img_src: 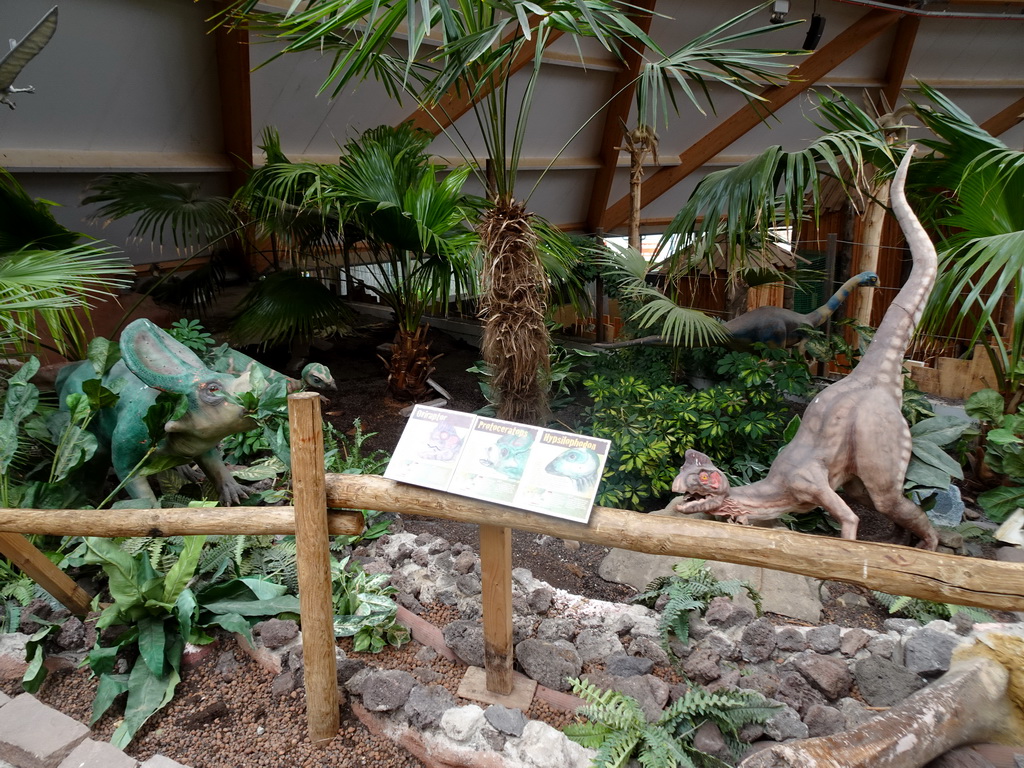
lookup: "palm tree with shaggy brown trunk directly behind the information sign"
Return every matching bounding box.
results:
[220,0,792,423]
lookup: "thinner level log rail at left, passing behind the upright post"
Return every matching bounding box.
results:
[0,507,364,539]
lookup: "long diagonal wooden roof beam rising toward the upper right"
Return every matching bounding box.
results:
[602,9,902,229]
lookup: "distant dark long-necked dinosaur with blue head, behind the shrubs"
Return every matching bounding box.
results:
[594,272,879,349]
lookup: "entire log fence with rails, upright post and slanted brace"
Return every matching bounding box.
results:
[0,394,1024,743]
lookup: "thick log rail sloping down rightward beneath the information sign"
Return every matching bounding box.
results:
[327,474,1024,610]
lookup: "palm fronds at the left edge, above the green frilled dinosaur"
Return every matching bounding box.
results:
[0,169,131,359]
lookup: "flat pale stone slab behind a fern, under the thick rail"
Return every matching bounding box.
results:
[598,548,821,624]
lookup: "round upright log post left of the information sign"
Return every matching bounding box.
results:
[288,392,341,745]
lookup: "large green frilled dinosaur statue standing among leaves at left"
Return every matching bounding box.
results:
[56,319,256,506]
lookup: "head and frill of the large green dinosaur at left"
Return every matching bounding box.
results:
[121,319,256,440]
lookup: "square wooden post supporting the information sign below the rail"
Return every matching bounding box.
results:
[480,525,514,695]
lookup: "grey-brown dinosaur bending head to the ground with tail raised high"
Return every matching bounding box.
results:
[672,147,938,550]
